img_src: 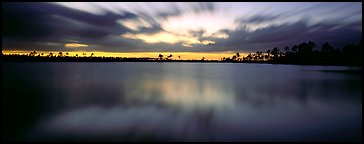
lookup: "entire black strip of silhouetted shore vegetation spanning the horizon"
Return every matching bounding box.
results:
[1,41,362,66]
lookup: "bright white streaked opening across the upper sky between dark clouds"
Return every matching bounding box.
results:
[55,2,362,36]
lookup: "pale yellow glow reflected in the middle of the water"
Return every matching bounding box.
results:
[134,76,235,109]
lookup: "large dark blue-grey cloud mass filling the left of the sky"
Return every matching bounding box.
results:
[2,3,137,50]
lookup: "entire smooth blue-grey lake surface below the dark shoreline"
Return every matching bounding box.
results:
[2,63,362,141]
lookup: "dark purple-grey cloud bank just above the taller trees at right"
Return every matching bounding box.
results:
[208,19,362,52]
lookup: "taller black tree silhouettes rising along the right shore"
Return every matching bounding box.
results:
[221,41,362,66]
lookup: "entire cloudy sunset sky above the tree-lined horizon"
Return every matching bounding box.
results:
[2,2,362,58]
